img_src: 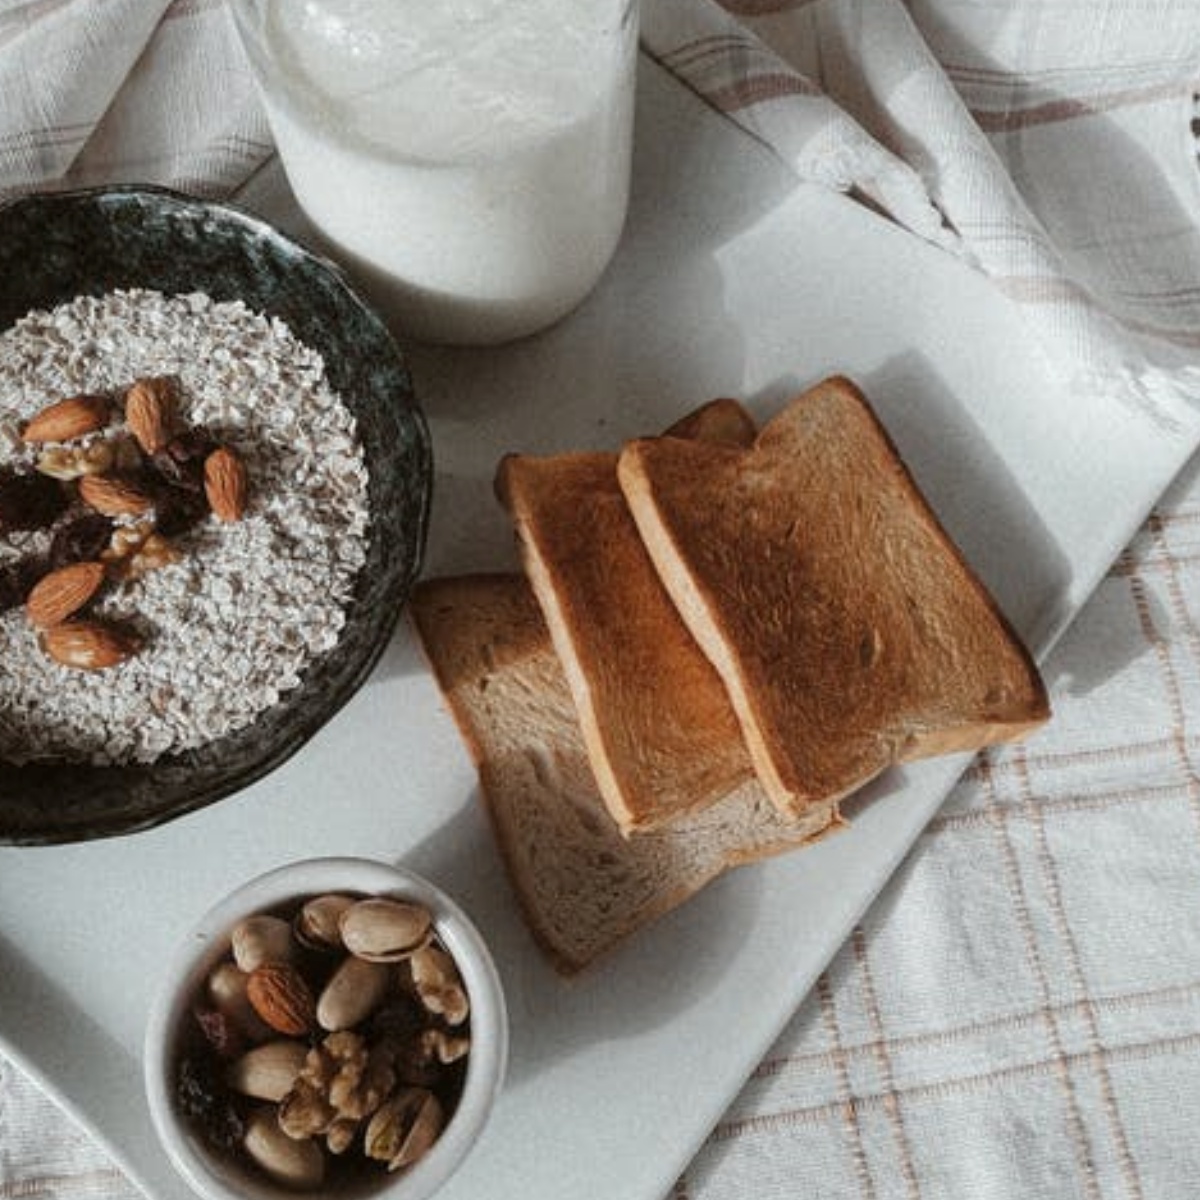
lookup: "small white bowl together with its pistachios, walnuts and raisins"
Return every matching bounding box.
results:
[144,858,508,1200]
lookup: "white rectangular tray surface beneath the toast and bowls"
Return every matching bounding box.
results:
[7,64,1196,1200]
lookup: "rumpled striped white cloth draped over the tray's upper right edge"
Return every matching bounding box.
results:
[643,0,1200,421]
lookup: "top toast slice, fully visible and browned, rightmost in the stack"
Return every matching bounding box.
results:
[618,378,1049,812]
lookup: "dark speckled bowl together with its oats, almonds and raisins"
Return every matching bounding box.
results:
[0,187,432,845]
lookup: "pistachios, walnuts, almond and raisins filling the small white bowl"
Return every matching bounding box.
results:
[175,894,470,1190]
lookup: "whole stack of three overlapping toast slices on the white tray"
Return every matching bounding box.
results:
[410,377,1049,973]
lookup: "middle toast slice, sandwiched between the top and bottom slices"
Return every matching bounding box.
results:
[496,400,756,834]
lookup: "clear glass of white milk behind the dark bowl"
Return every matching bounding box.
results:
[226,0,637,343]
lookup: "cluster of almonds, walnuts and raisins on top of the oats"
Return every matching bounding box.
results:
[0,376,247,671]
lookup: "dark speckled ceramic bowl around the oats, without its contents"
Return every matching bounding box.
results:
[0,187,433,845]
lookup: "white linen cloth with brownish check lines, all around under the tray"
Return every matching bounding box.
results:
[0,0,1200,1200]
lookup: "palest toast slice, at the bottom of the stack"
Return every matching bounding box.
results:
[409,575,840,974]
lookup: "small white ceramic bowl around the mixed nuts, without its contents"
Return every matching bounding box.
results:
[144,858,508,1200]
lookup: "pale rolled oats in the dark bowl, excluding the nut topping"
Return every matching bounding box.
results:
[0,290,368,763]
